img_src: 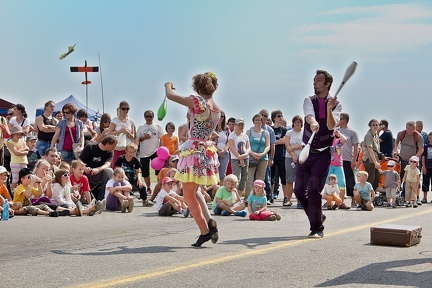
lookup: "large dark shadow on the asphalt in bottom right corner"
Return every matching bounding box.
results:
[315,258,432,287]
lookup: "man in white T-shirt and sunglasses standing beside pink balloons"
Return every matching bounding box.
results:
[136,110,163,194]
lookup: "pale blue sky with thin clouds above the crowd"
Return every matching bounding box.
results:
[0,0,432,138]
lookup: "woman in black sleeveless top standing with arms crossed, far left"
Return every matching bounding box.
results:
[36,100,59,157]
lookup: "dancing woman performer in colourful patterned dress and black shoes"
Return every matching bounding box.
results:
[165,72,220,247]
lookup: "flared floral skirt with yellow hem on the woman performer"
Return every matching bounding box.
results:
[174,139,219,185]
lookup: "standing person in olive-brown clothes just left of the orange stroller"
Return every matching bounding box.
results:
[358,119,381,191]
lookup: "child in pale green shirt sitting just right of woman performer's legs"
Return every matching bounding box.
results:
[212,174,247,217]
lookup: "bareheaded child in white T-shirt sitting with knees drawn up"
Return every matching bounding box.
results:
[105,167,134,213]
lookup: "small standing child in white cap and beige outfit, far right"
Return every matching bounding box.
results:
[403,156,420,208]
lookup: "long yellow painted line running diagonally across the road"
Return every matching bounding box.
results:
[74,209,432,288]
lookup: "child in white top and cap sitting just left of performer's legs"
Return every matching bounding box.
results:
[156,177,189,218]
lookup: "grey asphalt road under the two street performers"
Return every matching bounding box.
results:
[0,200,432,288]
